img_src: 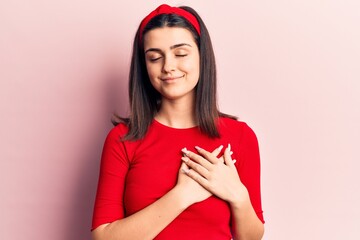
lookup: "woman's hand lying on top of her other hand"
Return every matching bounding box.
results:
[182,144,248,205]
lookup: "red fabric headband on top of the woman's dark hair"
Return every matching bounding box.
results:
[139,4,200,41]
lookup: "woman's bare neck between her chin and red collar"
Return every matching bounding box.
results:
[155,96,197,128]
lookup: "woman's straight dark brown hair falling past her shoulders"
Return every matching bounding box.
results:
[112,6,235,140]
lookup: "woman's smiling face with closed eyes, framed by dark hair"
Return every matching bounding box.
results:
[144,27,200,100]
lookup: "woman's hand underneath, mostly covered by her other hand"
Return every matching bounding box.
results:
[176,146,223,206]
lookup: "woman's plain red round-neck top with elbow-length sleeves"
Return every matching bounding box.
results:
[92,118,264,240]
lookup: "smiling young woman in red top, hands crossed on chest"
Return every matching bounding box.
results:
[92,5,264,240]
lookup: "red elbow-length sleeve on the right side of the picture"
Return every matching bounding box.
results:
[236,124,265,223]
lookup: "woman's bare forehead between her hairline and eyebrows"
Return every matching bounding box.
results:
[144,27,196,49]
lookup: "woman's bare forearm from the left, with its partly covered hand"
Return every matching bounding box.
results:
[92,160,211,240]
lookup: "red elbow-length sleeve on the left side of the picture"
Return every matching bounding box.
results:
[91,127,129,230]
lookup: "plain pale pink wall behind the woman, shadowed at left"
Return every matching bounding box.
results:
[0,0,360,240]
